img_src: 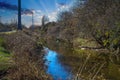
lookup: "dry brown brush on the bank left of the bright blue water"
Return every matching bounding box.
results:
[6,31,48,80]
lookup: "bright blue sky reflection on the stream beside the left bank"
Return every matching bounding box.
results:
[45,49,71,80]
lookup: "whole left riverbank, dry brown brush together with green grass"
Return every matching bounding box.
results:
[0,31,49,80]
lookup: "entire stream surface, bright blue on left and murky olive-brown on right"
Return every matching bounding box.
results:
[44,41,120,80]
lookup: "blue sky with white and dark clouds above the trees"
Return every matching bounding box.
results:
[0,0,75,27]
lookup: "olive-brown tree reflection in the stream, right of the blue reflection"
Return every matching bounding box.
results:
[44,38,119,80]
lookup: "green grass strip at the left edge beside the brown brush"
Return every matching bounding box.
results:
[0,37,11,79]
